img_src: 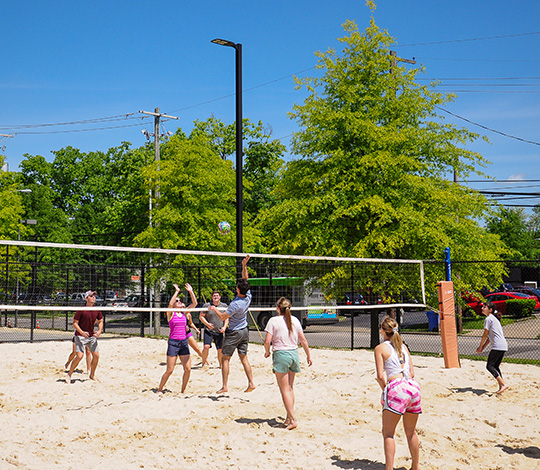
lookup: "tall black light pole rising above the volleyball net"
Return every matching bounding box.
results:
[211,39,244,253]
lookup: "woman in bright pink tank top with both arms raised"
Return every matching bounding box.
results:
[157,283,197,393]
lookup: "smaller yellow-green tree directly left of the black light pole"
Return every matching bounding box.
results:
[136,133,235,251]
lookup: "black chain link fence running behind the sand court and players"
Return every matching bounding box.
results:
[0,241,540,361]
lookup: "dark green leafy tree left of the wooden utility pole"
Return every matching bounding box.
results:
[21,142,150,245]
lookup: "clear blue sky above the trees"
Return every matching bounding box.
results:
[0,0,540,209]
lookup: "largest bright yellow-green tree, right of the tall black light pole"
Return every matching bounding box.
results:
[260,20,504,298]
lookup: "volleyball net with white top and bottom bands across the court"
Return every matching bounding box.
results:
[0,240,426,335]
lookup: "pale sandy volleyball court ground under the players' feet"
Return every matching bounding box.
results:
[0,338,540,470]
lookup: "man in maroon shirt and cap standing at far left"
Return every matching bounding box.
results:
[66,290,103,384]
